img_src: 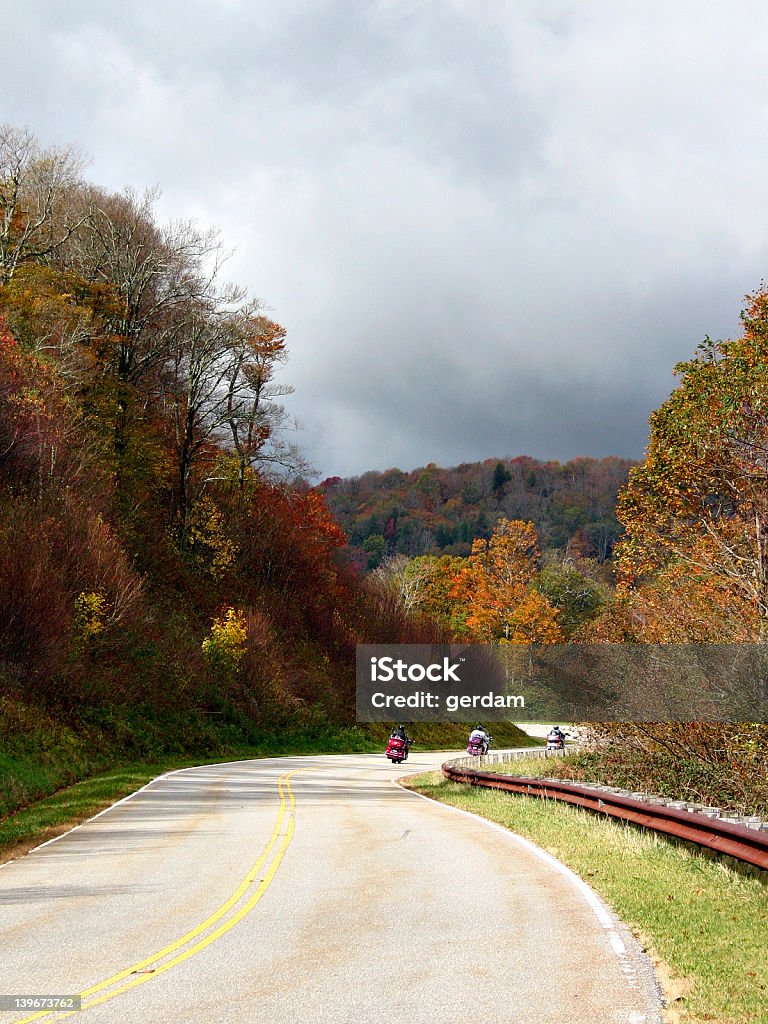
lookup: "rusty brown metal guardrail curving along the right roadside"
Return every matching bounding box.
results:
[442,761,768,869]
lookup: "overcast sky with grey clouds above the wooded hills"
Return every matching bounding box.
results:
[0,0,768,476]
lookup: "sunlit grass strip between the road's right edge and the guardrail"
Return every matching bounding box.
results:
[408,760,768,1024]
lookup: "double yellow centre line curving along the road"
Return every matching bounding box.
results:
[16,768,302,1024]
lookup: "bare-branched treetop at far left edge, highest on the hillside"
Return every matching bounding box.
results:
[0,124,87,285]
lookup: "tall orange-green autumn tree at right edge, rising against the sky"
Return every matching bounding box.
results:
[618,288,768,640]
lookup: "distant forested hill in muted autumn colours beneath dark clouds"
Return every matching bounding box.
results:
[321,456,635,568]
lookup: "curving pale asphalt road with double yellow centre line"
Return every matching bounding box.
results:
[0,752,659,1024]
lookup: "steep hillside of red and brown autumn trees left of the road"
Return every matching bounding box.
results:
[0,125,462,790]
